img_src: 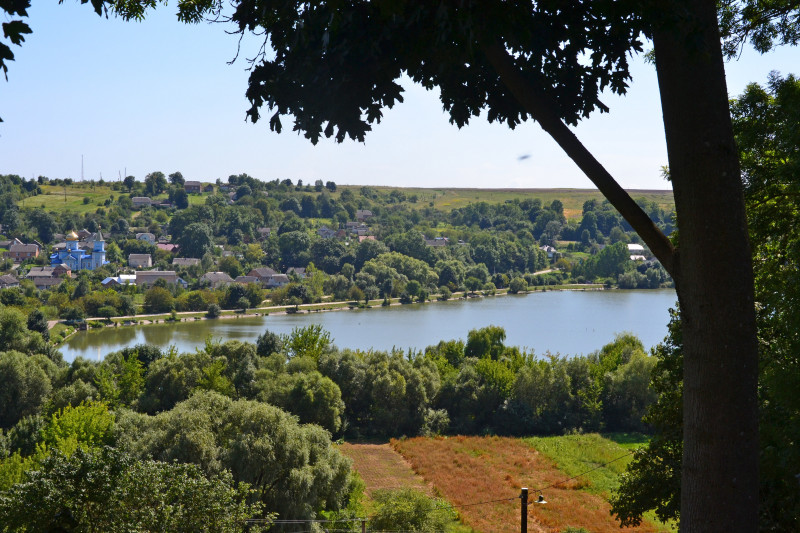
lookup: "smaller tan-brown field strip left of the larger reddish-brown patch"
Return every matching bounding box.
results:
[339,443,433,495]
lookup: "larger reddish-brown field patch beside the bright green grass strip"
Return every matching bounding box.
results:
[391,437,656,533]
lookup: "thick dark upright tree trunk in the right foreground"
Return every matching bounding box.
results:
[653,1,758,533]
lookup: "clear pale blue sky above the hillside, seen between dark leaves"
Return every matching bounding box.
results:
[0,0,800,189]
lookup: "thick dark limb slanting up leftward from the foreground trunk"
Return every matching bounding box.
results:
[483,42,677,278]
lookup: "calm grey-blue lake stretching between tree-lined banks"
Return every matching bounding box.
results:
[61,289,676,361]
